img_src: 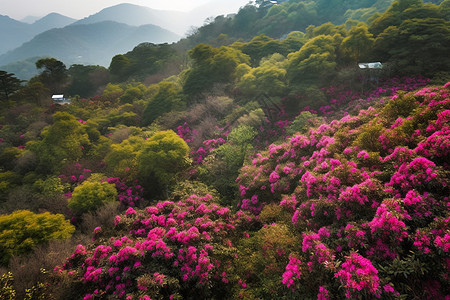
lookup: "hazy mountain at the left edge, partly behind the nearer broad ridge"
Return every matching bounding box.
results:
[0,13,76,54]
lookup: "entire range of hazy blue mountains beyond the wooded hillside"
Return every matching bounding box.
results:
[0,0,248,77]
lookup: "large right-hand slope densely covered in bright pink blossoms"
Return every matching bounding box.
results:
[237,83,450,299]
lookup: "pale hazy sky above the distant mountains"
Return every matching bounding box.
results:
[0,0,249,20]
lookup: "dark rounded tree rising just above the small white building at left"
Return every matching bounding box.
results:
[36,58,69,93]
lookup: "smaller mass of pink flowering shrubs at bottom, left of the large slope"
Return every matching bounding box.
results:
[60,195,252,299]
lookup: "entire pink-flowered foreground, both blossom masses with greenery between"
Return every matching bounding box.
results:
[60,83,450,299]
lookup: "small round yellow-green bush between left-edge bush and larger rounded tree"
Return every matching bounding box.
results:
[68,175,117,215]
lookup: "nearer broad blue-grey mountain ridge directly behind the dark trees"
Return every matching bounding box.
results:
[0,21,180,66]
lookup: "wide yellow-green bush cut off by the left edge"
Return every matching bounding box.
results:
[0,210,75,265]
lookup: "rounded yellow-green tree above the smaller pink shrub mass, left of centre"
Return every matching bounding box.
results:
[137,130,190,197]
